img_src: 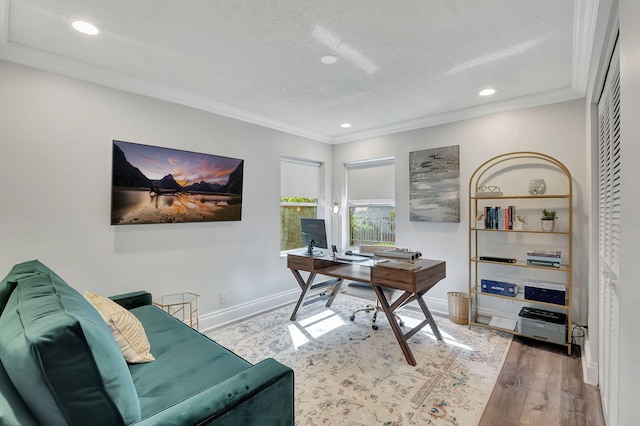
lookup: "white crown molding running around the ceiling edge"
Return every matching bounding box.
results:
[0,0,599,144]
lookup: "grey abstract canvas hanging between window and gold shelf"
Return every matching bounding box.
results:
[409,145,460,222]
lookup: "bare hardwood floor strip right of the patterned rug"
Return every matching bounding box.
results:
[480,337,605,426]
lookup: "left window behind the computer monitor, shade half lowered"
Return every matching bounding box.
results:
[280,158,322,251]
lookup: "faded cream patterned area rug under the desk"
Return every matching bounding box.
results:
[207,294,511,426]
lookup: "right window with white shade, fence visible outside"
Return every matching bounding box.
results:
[345,158,396,246]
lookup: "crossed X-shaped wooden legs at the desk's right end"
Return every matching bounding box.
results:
[373,285,442,366]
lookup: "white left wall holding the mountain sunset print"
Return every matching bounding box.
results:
[0,62,331,326]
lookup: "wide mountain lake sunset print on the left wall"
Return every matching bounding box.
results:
[111,140,244,225]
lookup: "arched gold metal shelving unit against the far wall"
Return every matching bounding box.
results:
[469,152,573,354]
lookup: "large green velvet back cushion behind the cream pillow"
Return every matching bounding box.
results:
[0,264,140,425]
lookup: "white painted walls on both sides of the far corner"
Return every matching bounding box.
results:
[0,62,586,327]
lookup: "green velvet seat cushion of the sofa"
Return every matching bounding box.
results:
[129,306,251,418]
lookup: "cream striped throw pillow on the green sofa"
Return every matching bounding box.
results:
[84,291,155,364]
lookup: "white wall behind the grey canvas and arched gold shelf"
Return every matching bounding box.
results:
[333,100,587,324]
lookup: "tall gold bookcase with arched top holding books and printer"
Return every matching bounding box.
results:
[468,151,573,354]
